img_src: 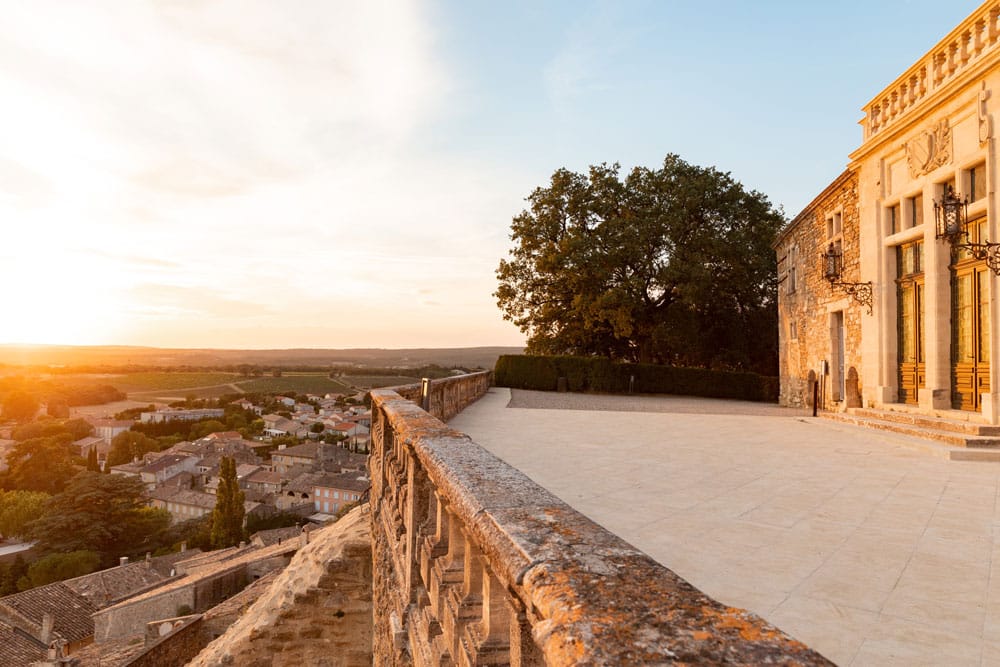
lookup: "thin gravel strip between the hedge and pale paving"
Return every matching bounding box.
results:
[507,389,807,417]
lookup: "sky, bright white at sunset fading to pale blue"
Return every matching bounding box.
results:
[0,0,979,348]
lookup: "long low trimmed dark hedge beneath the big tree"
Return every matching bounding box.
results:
[494,354,778,402]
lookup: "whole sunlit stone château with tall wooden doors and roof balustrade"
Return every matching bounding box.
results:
[775,2,1000,424]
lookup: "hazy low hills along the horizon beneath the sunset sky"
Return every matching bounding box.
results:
[0,345,524,368]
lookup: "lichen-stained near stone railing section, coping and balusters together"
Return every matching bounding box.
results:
[370,378,830,665]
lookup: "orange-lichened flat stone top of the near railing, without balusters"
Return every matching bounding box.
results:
[371,390,832,665]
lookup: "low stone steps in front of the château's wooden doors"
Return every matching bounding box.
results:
[820,406,1000,463]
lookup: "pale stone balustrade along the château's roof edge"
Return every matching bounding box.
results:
[861,3,1000,141]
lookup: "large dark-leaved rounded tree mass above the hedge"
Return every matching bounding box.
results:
[494,155,784,375]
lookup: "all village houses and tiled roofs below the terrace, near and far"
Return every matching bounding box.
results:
[0,394,371,666]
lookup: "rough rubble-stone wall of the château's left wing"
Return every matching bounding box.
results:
[775,170,867,410]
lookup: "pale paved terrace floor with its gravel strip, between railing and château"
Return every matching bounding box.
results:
[450,388,1000,666]
